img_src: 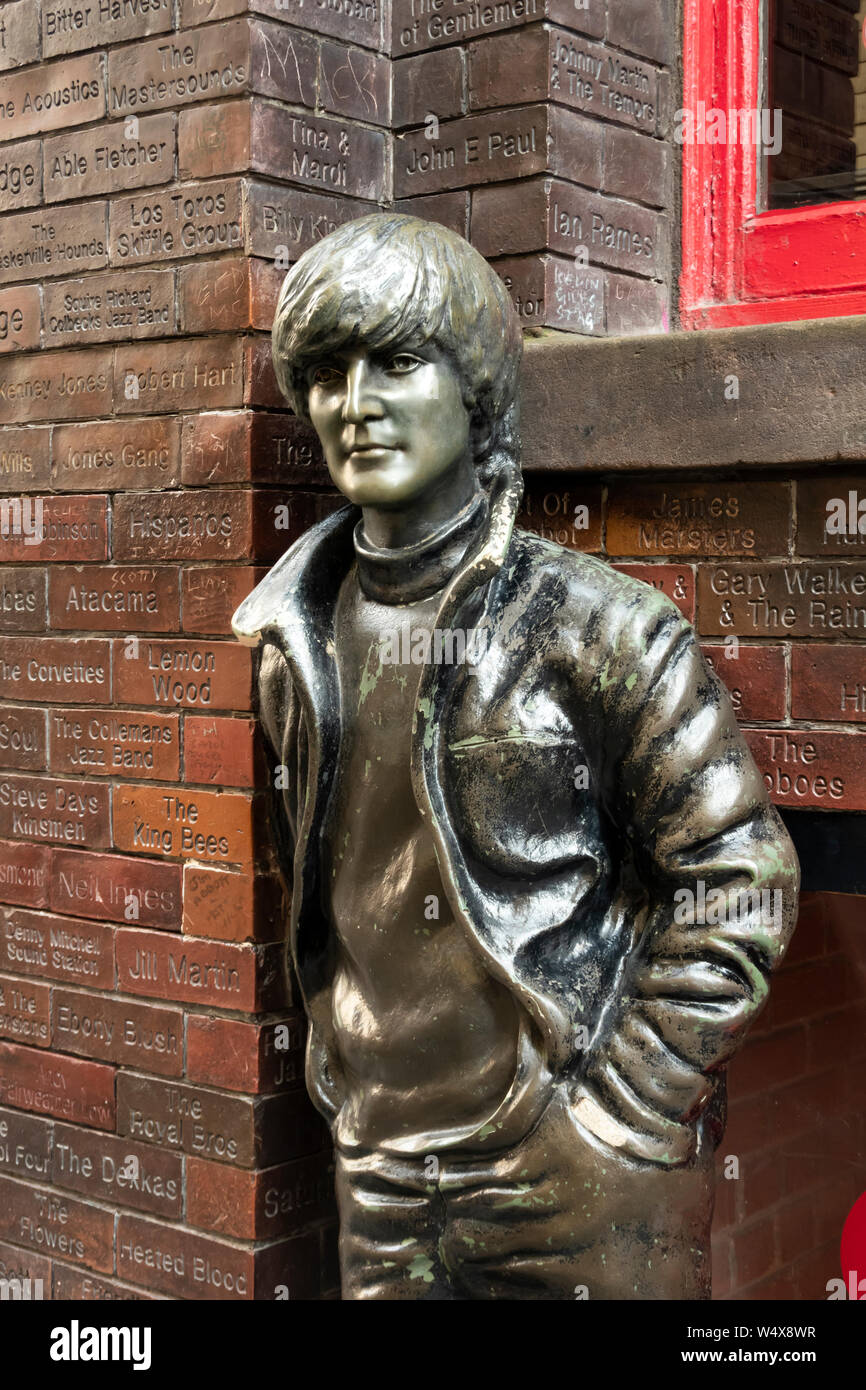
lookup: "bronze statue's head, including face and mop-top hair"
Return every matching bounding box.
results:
[272,213,523,506]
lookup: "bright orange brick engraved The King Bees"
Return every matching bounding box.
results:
[112,783,253,865]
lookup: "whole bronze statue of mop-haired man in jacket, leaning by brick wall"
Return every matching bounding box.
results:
[234,214,798,1300]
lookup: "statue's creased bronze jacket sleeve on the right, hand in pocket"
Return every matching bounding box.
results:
[574,595,799,1165]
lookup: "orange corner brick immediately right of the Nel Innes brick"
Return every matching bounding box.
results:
[183,862,285,941]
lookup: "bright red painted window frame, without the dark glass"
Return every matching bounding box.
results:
[680,0,866,328]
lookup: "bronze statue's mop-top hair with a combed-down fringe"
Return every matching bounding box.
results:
[272,213,523,480]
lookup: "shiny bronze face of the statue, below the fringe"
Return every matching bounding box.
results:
[307,343,470,509]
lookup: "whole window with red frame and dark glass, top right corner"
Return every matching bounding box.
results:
[677,0,866,328]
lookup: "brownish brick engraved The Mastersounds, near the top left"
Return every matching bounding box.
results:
[108,19,250,115]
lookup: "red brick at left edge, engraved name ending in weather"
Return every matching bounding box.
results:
[0,1043,114,1128]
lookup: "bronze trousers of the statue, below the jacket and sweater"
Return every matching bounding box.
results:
[336,1083,713,1301]
